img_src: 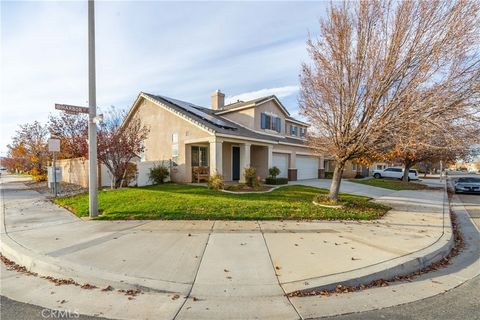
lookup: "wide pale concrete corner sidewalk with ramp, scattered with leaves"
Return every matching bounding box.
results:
[1,176,458,319]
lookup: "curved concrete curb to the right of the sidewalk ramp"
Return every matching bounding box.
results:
[281,184,455,293]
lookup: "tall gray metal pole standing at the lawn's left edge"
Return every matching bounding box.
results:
[88,0,98,217]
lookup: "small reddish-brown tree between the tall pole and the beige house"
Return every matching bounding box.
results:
[98,107,149,188]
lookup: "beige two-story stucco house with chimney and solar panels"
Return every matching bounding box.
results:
[124,90,324,182]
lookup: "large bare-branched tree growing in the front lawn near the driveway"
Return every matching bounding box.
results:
[299,0,480,200]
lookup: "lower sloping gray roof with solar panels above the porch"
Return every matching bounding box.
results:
[143,92,304,146]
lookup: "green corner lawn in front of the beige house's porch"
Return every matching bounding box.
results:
[55,184,389,220]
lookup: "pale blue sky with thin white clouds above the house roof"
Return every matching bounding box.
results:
[0,1,328,155]
